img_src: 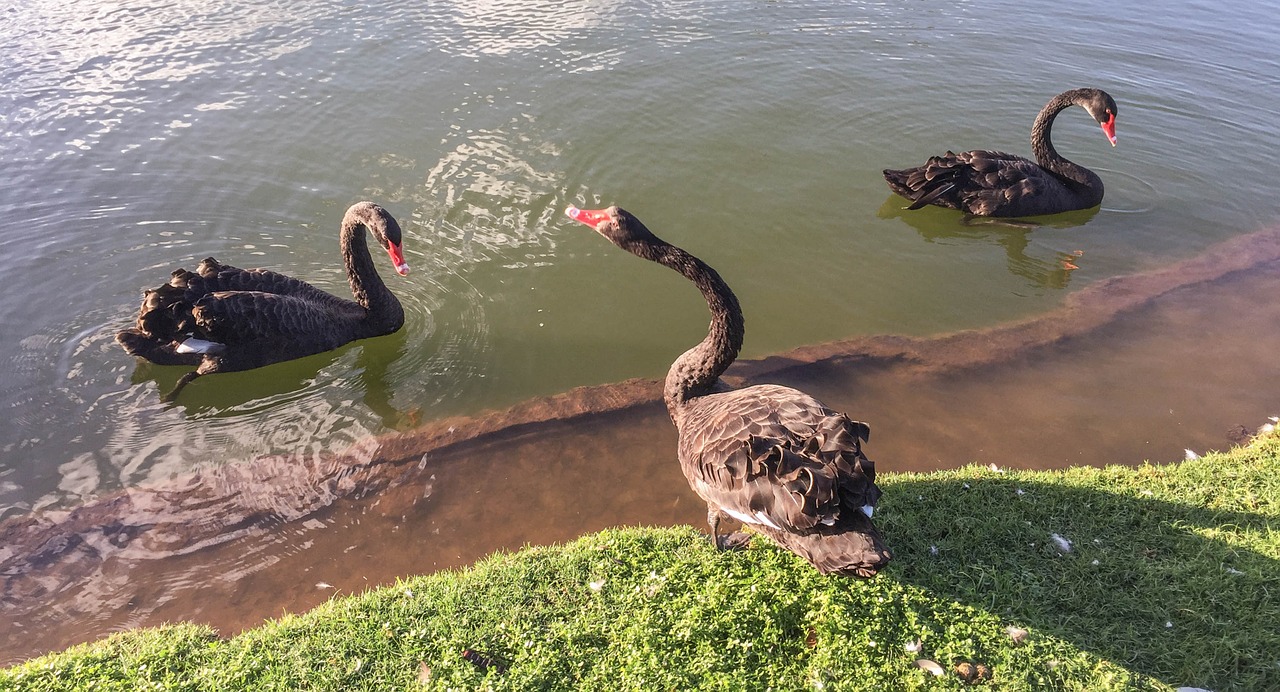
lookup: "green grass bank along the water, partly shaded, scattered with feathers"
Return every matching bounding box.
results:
[0,435,1280,692]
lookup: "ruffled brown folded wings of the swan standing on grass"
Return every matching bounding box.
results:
[680,385,879,532]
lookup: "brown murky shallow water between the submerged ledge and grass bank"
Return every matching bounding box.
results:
[0,230,1280,663]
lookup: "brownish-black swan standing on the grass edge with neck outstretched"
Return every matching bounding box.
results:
[567,206,890,577]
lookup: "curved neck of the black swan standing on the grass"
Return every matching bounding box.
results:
[628,240,744,426]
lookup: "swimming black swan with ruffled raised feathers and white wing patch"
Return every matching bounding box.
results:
[115,202,408,399]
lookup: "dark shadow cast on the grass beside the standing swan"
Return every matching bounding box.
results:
[877,469,1280,689]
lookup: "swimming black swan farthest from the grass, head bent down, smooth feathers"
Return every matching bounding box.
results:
[884,88,1116,216]
